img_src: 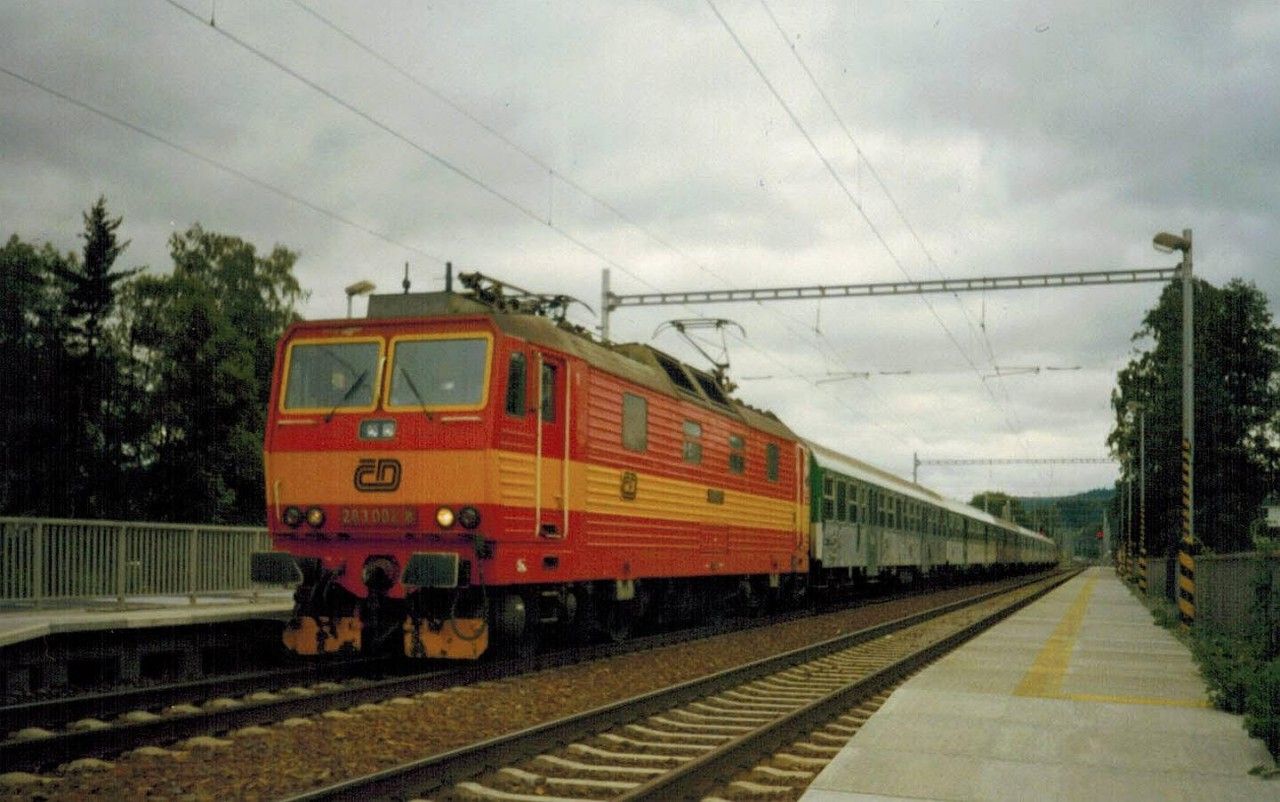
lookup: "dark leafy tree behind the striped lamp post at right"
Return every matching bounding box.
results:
[1107,279,1280,554]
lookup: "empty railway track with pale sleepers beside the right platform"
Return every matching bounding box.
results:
[288,574,1074,802]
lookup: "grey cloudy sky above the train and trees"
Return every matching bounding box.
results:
[0,0,1280,498]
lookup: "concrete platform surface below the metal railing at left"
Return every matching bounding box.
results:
[0,590,293,647]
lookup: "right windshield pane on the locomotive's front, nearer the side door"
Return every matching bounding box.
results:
[387,336,490,409]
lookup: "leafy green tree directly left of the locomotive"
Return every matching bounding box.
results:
[129,225,303,523]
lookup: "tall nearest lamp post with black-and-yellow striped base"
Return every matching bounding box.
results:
[1151,229,1196,627]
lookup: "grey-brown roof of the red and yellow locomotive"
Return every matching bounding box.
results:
[367,292,799,440]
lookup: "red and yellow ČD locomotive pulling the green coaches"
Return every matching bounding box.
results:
[253,274,809,659]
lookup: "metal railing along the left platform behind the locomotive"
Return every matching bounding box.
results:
[0,517,271,605]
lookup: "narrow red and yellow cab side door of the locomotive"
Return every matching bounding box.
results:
[534,352,570,537]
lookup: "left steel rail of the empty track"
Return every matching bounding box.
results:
[275,572,1078,802]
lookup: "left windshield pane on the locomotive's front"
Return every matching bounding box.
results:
[284,340,379,412]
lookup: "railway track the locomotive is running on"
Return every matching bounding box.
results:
[0,570,1039,771]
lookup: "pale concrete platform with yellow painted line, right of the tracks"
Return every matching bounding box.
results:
[801,568,1280,802]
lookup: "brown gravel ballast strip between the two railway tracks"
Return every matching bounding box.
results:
[0,583,1039,802]
